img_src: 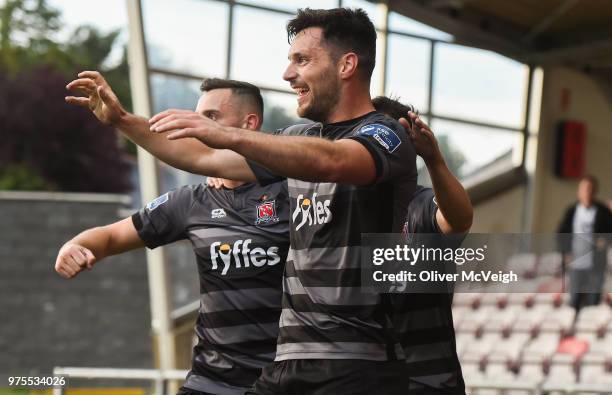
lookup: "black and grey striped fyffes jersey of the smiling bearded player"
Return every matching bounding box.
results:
[250,112,416,361]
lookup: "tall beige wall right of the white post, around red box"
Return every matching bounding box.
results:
[533,68,612,232]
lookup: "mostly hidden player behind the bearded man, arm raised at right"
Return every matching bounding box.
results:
[372,96,474,395]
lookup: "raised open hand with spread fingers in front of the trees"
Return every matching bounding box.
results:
[66,71,126,125]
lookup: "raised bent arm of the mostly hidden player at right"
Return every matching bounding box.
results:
[400,112,474,234]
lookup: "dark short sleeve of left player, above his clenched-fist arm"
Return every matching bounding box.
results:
[132,185,200,248]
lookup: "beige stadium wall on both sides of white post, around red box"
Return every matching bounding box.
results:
[472,67,612,232]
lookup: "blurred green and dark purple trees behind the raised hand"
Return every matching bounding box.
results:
[0,0,131,192]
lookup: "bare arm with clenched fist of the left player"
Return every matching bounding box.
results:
[55,218,144,278]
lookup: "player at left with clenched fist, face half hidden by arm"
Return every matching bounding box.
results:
[61,74,289,395]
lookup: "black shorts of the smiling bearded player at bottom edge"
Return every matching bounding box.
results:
[246,359,409,395]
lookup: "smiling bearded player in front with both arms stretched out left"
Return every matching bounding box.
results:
[69,8,416,394]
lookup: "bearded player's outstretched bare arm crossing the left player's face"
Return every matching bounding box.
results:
[150,110,376,185]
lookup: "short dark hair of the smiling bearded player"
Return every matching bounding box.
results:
[287,8,376,81]
